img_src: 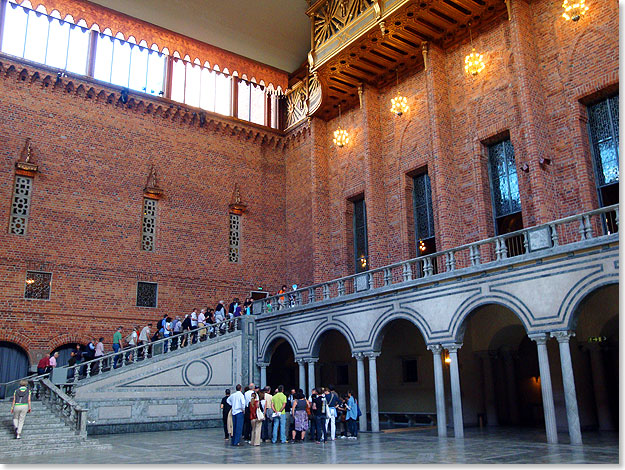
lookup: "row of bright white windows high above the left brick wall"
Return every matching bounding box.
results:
[0,0,278,128]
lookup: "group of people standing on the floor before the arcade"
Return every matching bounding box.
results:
[220,383,361,446]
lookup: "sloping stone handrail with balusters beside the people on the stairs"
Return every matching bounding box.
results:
[60,316,243,384]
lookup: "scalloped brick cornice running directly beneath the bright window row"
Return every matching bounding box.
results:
[0,54,286,150]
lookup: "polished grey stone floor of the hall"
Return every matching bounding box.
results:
[0,428,619,464]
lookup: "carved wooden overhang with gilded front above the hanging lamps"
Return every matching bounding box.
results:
[304,0,507,120]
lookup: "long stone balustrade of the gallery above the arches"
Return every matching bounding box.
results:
[253,204,619,315]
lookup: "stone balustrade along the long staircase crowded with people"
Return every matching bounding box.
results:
[58,317,242,384]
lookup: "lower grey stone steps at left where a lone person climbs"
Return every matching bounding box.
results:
[0,400,111,456]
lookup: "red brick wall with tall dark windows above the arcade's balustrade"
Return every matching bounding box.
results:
[286,0,618,282]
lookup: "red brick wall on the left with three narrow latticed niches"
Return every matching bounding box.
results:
[0,59,286,361]
